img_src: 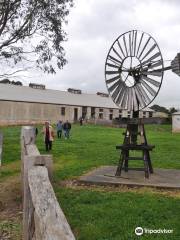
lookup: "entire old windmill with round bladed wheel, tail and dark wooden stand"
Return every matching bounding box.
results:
[105,30,180,178]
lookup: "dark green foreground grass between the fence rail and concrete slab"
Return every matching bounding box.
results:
[56,188,180,240]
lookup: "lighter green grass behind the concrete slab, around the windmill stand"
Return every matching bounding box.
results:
[37,125,180,179]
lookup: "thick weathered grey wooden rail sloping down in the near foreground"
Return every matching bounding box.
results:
[28,166,75,240]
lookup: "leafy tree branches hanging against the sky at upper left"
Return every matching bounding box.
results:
[0,0,73,78]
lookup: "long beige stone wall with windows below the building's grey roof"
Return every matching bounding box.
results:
[0,100,167,125]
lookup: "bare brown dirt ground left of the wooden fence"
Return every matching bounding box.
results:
[0,176,22,240]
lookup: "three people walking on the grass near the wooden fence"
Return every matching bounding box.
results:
[42,121,71,151]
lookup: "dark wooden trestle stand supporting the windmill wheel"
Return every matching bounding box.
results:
[115,112,155,178]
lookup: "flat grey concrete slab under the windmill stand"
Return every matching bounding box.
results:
[78,166,180,189]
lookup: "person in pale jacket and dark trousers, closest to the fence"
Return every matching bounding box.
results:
[42,121,54,151]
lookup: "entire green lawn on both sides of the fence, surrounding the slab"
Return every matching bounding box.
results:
[0,125,180,240]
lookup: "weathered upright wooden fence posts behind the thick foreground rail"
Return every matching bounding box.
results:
[21,126,52,240]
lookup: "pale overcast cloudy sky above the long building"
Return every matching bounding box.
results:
[23,0,180,108]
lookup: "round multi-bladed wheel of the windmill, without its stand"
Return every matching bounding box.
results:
[105,30,165,111]
